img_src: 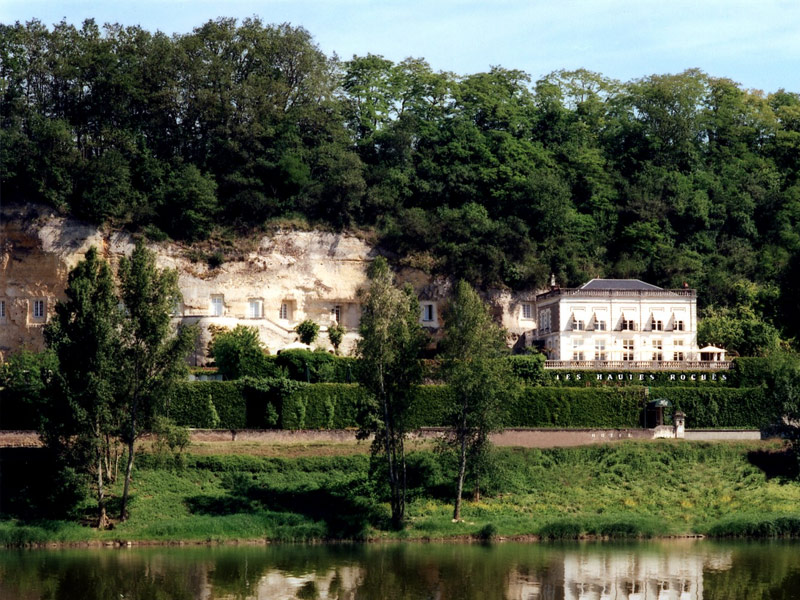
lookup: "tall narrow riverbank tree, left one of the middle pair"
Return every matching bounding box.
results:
[356,257,427,529]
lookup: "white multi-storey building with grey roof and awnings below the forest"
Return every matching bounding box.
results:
[534,279,712,369]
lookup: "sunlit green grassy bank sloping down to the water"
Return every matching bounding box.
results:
[0,441,800,544]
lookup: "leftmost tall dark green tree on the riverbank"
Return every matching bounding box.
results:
[40,247,121,529]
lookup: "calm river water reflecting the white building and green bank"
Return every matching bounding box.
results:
[0,540,800,600]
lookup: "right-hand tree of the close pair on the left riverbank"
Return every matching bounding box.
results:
[116,241,197,520]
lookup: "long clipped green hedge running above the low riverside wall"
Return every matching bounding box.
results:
[164,379,780,429]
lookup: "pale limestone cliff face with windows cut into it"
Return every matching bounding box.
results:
[0,206,533,365]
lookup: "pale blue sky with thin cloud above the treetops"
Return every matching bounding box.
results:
[0,0,800,92]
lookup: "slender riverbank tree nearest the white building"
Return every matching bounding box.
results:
[441,281,514,520]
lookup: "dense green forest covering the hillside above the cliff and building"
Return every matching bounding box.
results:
[0,19,800,354]
